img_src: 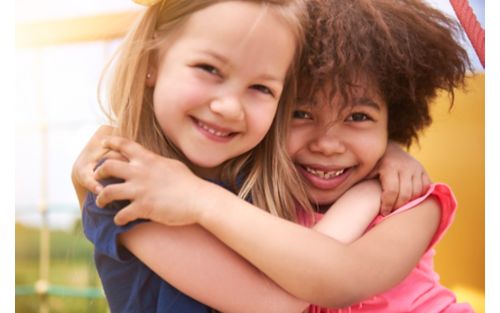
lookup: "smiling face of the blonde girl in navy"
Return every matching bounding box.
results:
[152,1,295,178]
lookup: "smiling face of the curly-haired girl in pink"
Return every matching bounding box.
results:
[287,85,388,205]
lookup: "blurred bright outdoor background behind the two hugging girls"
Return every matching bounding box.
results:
[15,0,485,313]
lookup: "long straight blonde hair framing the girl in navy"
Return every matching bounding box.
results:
[100,0,309,221]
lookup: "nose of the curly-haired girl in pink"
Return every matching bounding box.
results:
[309,127,346,156]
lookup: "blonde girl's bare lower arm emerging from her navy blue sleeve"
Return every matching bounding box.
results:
[122,223,308,313]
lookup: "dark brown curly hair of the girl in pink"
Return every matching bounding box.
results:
[299,0,470,146]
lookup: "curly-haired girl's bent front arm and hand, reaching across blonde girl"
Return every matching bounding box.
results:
[96,138,439,307]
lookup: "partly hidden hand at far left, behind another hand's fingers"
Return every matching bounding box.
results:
[71,125,116,207]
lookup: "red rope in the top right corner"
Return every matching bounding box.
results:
[450,0,485,68]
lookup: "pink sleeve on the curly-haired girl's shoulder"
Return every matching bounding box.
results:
[373,183,457,249]
